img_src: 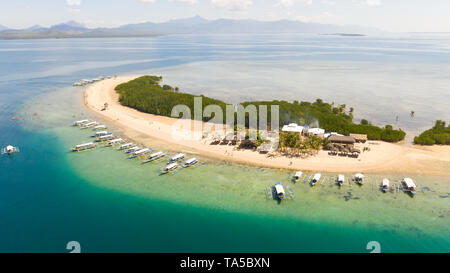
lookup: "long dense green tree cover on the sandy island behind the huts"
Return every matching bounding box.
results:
[116,76,405,142]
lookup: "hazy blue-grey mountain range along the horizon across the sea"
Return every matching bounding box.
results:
[0,16,381,39]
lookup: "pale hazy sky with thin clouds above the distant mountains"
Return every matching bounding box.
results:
[0,0,450,32]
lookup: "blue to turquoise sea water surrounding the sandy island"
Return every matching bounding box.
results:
[0,35,450,252]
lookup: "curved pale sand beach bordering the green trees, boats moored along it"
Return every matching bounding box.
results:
[84,76,450,175]
